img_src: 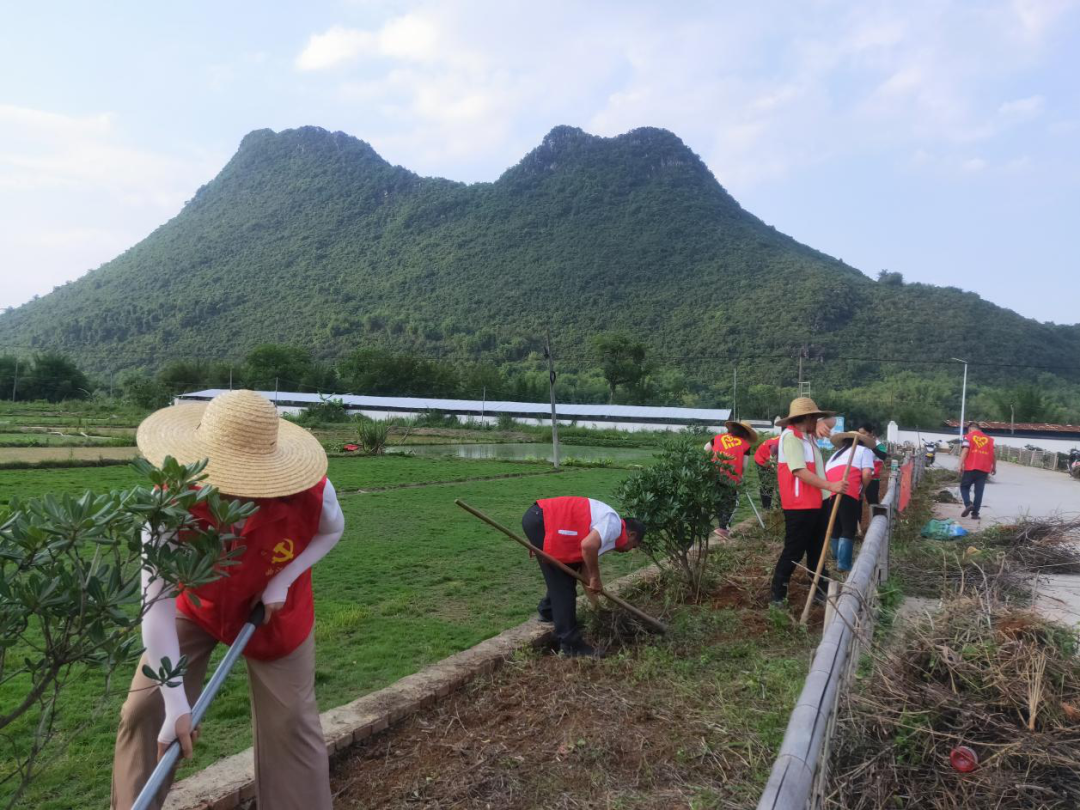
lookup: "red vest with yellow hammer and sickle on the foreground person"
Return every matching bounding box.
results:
[176,478,326,661]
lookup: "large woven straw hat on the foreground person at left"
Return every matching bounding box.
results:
[135,391,326,498]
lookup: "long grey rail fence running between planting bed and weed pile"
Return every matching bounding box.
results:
[757,453,923,810]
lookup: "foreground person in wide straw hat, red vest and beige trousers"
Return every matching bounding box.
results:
[112,391,345,810]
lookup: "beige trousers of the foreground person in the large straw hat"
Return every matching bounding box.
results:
[112,618,332,810]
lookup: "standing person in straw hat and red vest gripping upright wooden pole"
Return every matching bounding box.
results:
[772,396,847,604]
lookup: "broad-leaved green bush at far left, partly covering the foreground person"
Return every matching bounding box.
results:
[0,458,255,807]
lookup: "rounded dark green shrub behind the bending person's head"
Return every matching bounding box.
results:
[619,435,737,592]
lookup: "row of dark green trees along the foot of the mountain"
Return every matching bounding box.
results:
[0,343,1080,427]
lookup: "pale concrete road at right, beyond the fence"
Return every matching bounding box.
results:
[934,455,1080,625]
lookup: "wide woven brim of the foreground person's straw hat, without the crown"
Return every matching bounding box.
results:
[135,403,327,498]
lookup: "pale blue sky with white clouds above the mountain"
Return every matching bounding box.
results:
[0,0,1080,323]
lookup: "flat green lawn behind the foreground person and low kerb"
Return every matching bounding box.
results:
[0,457,646,810]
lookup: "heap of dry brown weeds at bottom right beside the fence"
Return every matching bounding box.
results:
[825,599,1080,810]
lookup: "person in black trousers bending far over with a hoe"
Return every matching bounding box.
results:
[522,497,645,658]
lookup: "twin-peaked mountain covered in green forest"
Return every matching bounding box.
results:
[0,126,1080,384]
